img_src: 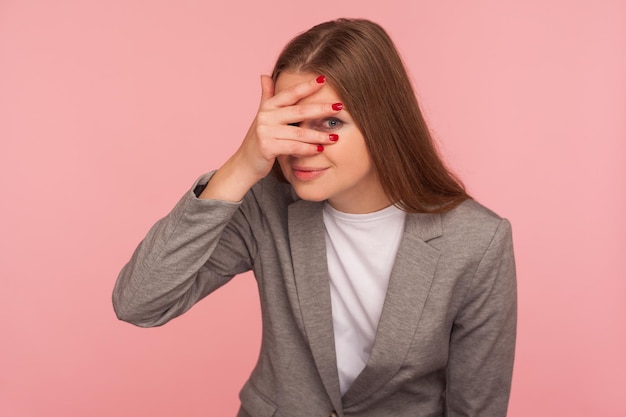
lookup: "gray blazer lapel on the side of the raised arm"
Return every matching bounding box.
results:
[288,200,342,410]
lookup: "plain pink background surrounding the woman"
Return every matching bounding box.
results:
[0,0,626,417]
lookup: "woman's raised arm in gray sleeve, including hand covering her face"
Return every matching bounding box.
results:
[113,76,339,327]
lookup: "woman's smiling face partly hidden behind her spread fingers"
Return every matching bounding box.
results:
[275,72,391,213]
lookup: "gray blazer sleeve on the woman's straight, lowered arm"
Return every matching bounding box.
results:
[446,219,517,417]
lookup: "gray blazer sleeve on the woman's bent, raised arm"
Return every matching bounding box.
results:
[113,174,255,327]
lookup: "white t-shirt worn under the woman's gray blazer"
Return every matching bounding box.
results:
[324,203,406,395]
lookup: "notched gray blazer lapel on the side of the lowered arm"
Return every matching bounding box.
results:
[343,214,442,407]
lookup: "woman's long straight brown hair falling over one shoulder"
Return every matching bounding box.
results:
[272,19,470,213]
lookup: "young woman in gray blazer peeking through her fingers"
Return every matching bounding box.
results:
[113,19,516,417]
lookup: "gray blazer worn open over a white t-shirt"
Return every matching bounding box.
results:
[113,174,516,417]
